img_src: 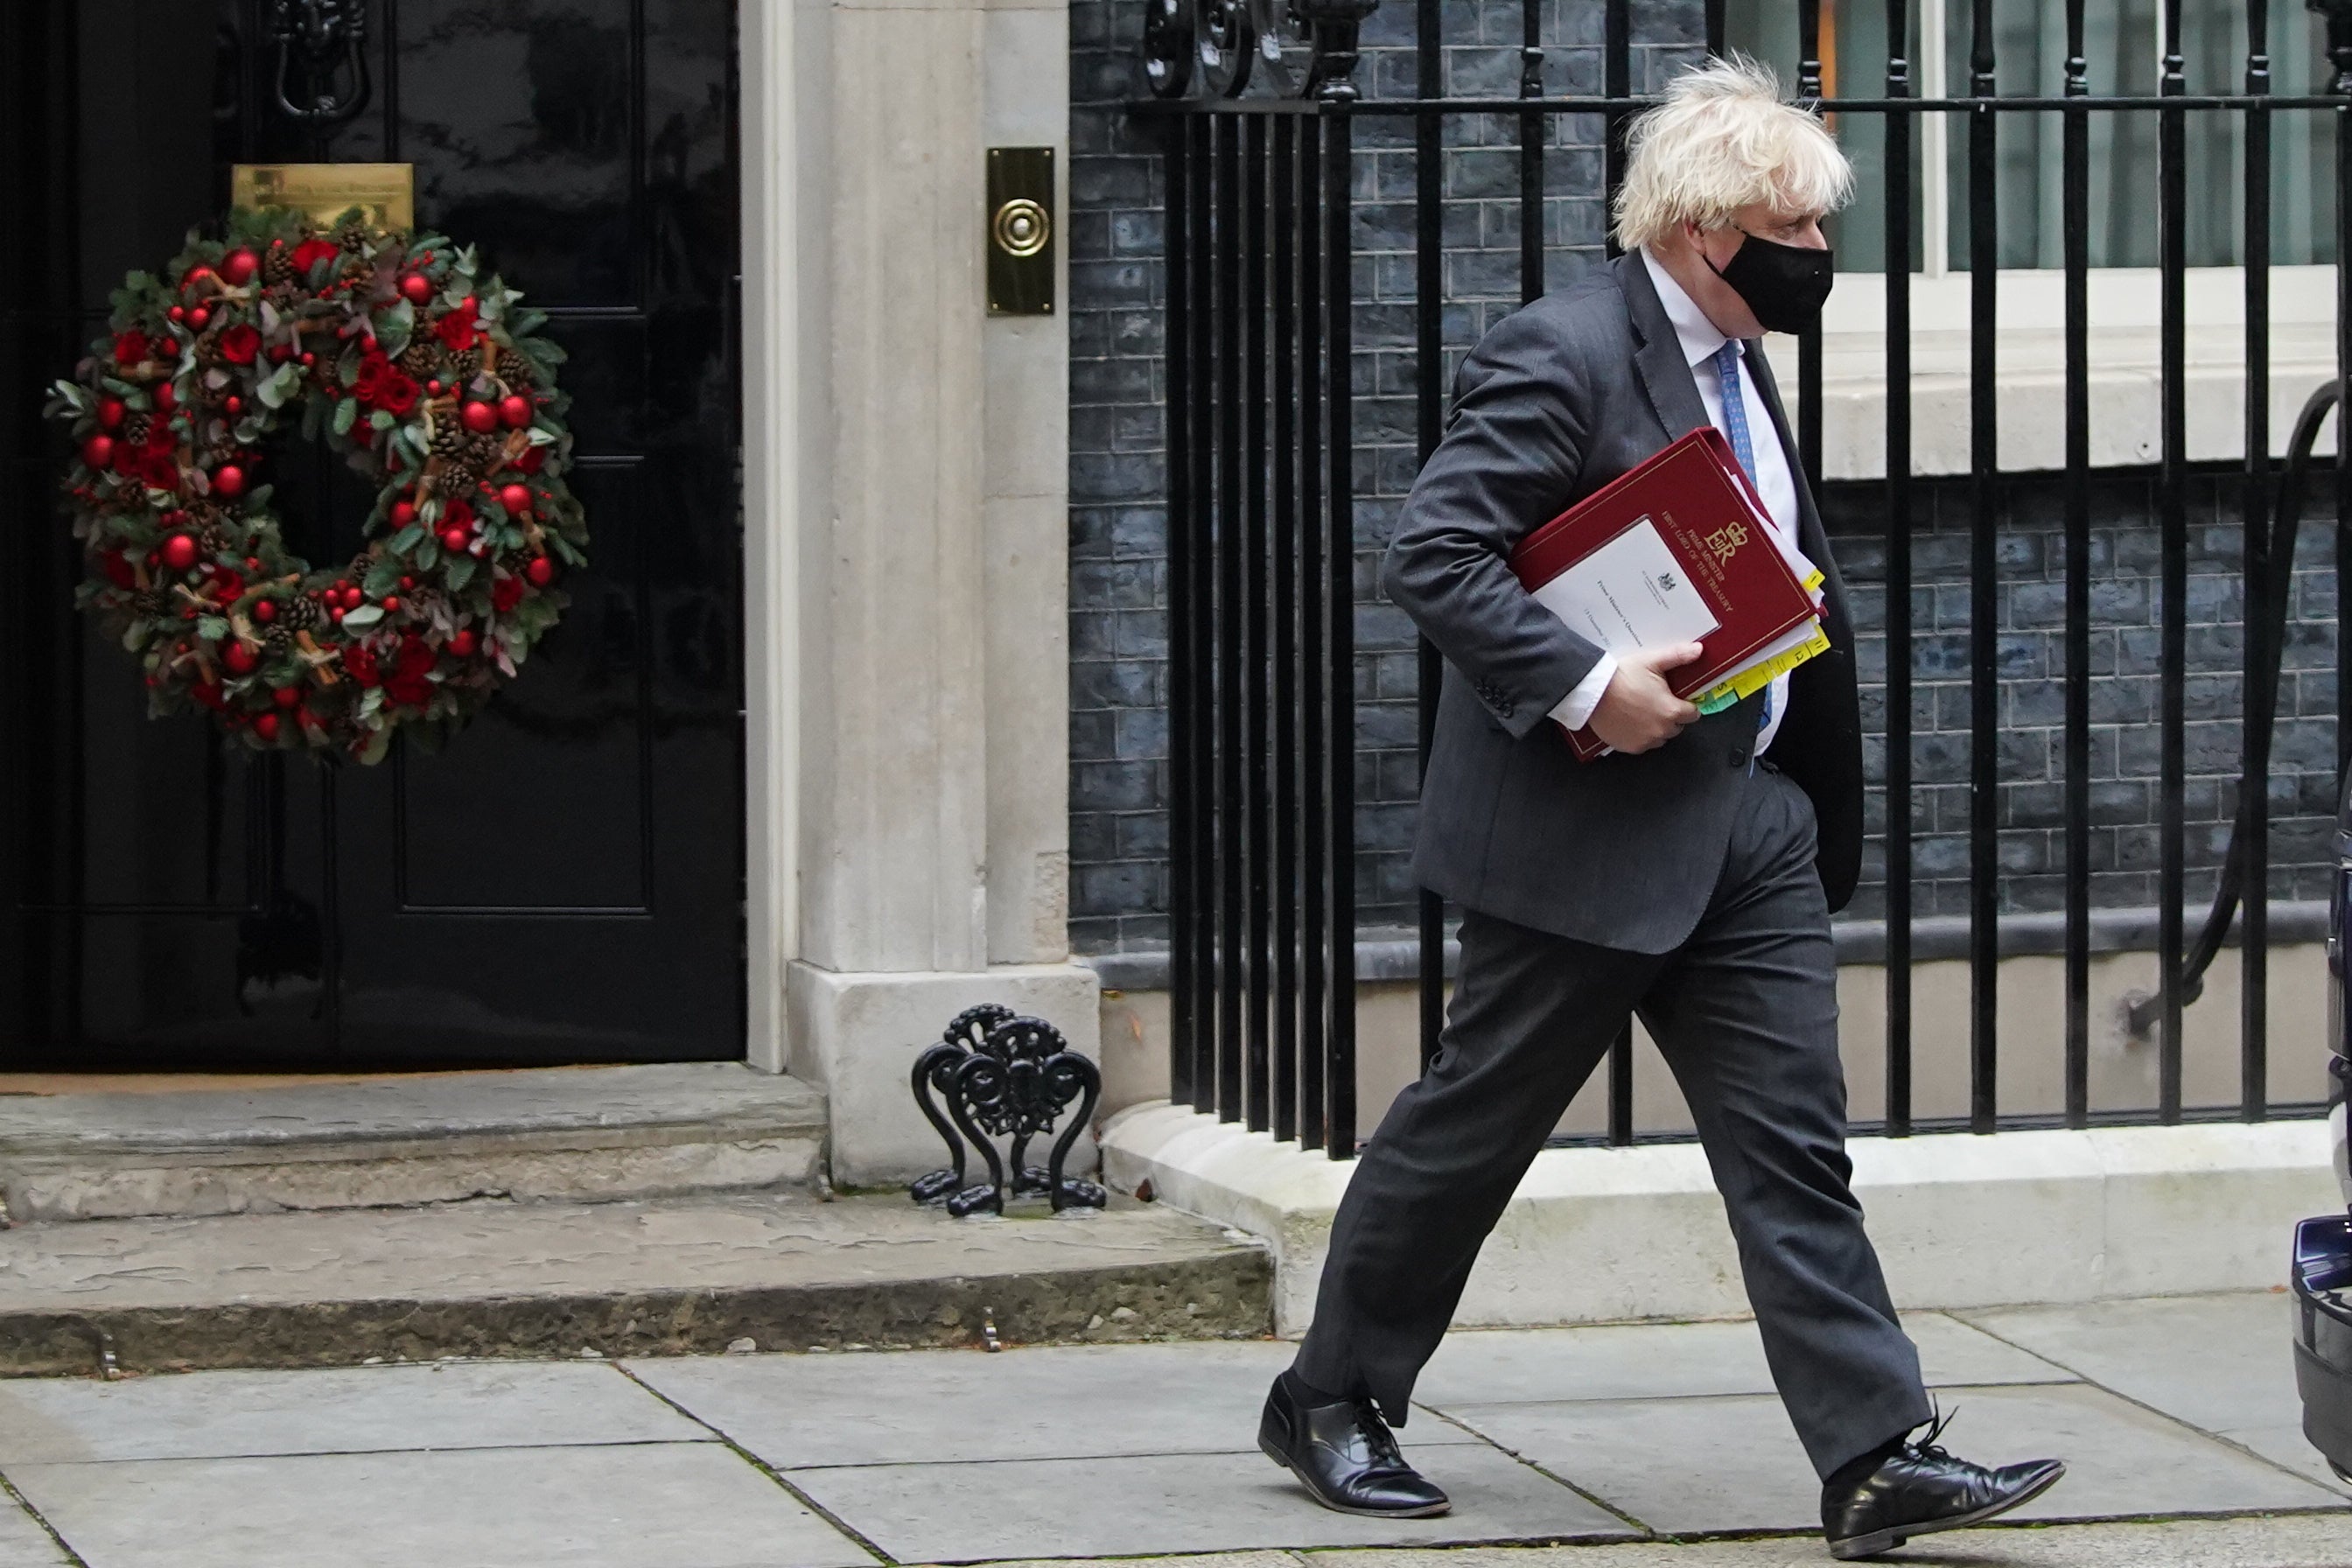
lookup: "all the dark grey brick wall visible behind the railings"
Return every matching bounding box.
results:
[1068,0,2333,952]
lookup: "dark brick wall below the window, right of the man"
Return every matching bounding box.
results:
[1823,470,2335,917]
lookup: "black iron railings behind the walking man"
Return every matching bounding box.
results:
[1136,0,2352,1159]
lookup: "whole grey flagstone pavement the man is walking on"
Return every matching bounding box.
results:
[0,1298,2352,1568]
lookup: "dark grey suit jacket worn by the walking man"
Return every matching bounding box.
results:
[1383,254,1863,952]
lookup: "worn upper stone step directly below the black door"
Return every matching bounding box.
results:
[0,1062,825,1225]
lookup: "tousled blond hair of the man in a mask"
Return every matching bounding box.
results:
[1616,54,1853,249]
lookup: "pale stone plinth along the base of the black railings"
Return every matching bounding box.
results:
[1103,1100,2342,1335]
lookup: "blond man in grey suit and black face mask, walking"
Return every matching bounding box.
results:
[1258,61,2065,1558]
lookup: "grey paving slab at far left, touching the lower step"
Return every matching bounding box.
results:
[0,1362,712,1466]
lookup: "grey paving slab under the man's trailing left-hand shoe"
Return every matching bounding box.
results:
[790,1444,1632,1568]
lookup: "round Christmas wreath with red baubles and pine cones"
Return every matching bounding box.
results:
[47,209,588,761]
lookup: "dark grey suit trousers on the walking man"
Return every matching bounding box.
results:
[1296,766,1928,1476]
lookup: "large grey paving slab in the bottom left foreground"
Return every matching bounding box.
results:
[7,1444,872,1568]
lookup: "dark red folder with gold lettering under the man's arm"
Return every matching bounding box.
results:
[1510,425,1821,761]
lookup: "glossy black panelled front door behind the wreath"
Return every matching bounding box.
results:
[0,0,743,1072]
